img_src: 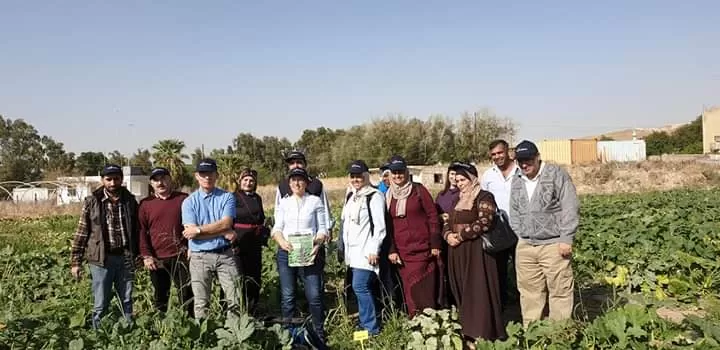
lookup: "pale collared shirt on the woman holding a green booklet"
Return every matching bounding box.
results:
[273,193,328,239]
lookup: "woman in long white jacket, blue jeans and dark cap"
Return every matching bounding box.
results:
[341,160,386,335]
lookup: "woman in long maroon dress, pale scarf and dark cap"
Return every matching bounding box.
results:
[385,156,443,318]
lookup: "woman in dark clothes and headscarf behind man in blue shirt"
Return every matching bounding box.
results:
[232,169,270,313]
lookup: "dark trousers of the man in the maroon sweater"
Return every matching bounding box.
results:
[150,256,194,317]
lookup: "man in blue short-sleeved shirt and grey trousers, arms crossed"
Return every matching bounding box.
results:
[182,158,240,320]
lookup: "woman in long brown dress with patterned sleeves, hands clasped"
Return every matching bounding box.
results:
[443,163,506,348]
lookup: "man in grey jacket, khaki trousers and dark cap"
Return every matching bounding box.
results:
[510,141,580,327]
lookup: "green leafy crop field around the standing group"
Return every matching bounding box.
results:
[0,190,720,349]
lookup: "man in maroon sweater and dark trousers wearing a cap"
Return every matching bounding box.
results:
[138,168,194,317]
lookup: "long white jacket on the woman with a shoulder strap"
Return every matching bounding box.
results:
[340,189,387,274]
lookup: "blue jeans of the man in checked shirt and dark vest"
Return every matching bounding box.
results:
[90,255,134,328]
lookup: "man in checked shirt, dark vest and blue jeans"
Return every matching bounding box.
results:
[71,164,139,328]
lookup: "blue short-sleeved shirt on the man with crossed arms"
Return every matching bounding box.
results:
[182,188,236,252]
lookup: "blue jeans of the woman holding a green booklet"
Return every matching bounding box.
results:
[277,249,325,340]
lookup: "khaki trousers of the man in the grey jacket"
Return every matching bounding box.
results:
[515,239,575,327]
